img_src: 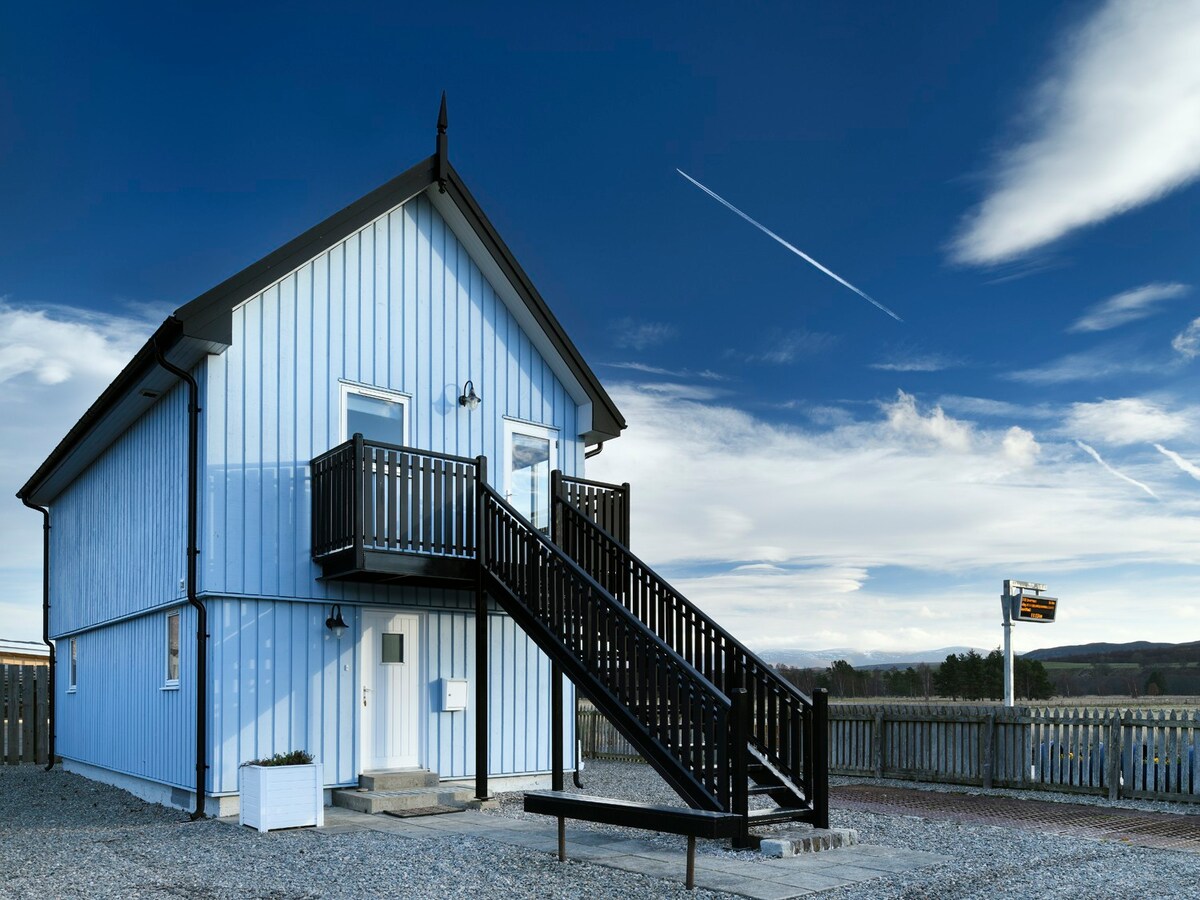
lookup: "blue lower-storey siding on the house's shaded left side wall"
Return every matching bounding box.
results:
[54,604,195,790]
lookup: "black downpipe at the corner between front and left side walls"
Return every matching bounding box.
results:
[154,342,209,820]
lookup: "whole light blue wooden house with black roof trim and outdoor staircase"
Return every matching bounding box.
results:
[18,104,824,844]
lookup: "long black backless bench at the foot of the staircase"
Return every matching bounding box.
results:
[524,791,742,890]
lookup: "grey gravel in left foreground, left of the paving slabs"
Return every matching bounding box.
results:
[0,766,730,900]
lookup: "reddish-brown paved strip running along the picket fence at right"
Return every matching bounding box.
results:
[829,785,1200,852]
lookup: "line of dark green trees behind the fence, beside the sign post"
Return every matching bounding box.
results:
[776,649,1055,700]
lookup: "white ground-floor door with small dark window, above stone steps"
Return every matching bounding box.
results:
[360,610,421,772]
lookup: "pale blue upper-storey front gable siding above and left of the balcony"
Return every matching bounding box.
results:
[202,196,582,601]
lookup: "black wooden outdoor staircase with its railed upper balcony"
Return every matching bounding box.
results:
[311,434,829,846]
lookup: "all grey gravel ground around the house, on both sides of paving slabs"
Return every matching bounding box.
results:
[7,762,1200,900]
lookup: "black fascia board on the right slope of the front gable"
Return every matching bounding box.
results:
[446,166,626,439]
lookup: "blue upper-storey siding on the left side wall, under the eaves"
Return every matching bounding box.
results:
[50,385,187,636]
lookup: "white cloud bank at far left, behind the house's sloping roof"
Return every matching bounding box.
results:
[0,300,158,641]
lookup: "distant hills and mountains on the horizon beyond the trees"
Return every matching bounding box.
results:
[758,641,1200,668]
